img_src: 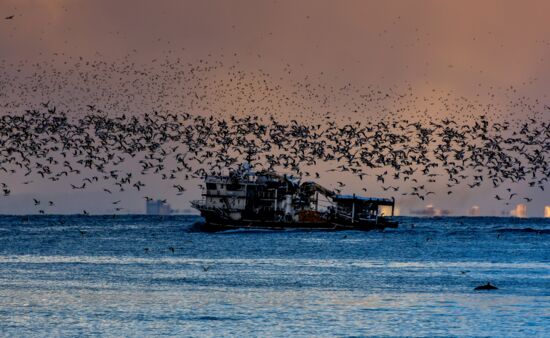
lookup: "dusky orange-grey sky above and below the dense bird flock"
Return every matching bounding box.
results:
[0,0,550,215]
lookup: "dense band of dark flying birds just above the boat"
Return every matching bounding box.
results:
[0,102,550,213]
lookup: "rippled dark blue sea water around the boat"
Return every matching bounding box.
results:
[0,216,550,337]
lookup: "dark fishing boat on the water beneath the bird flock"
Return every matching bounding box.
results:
[191,164,398,231]
